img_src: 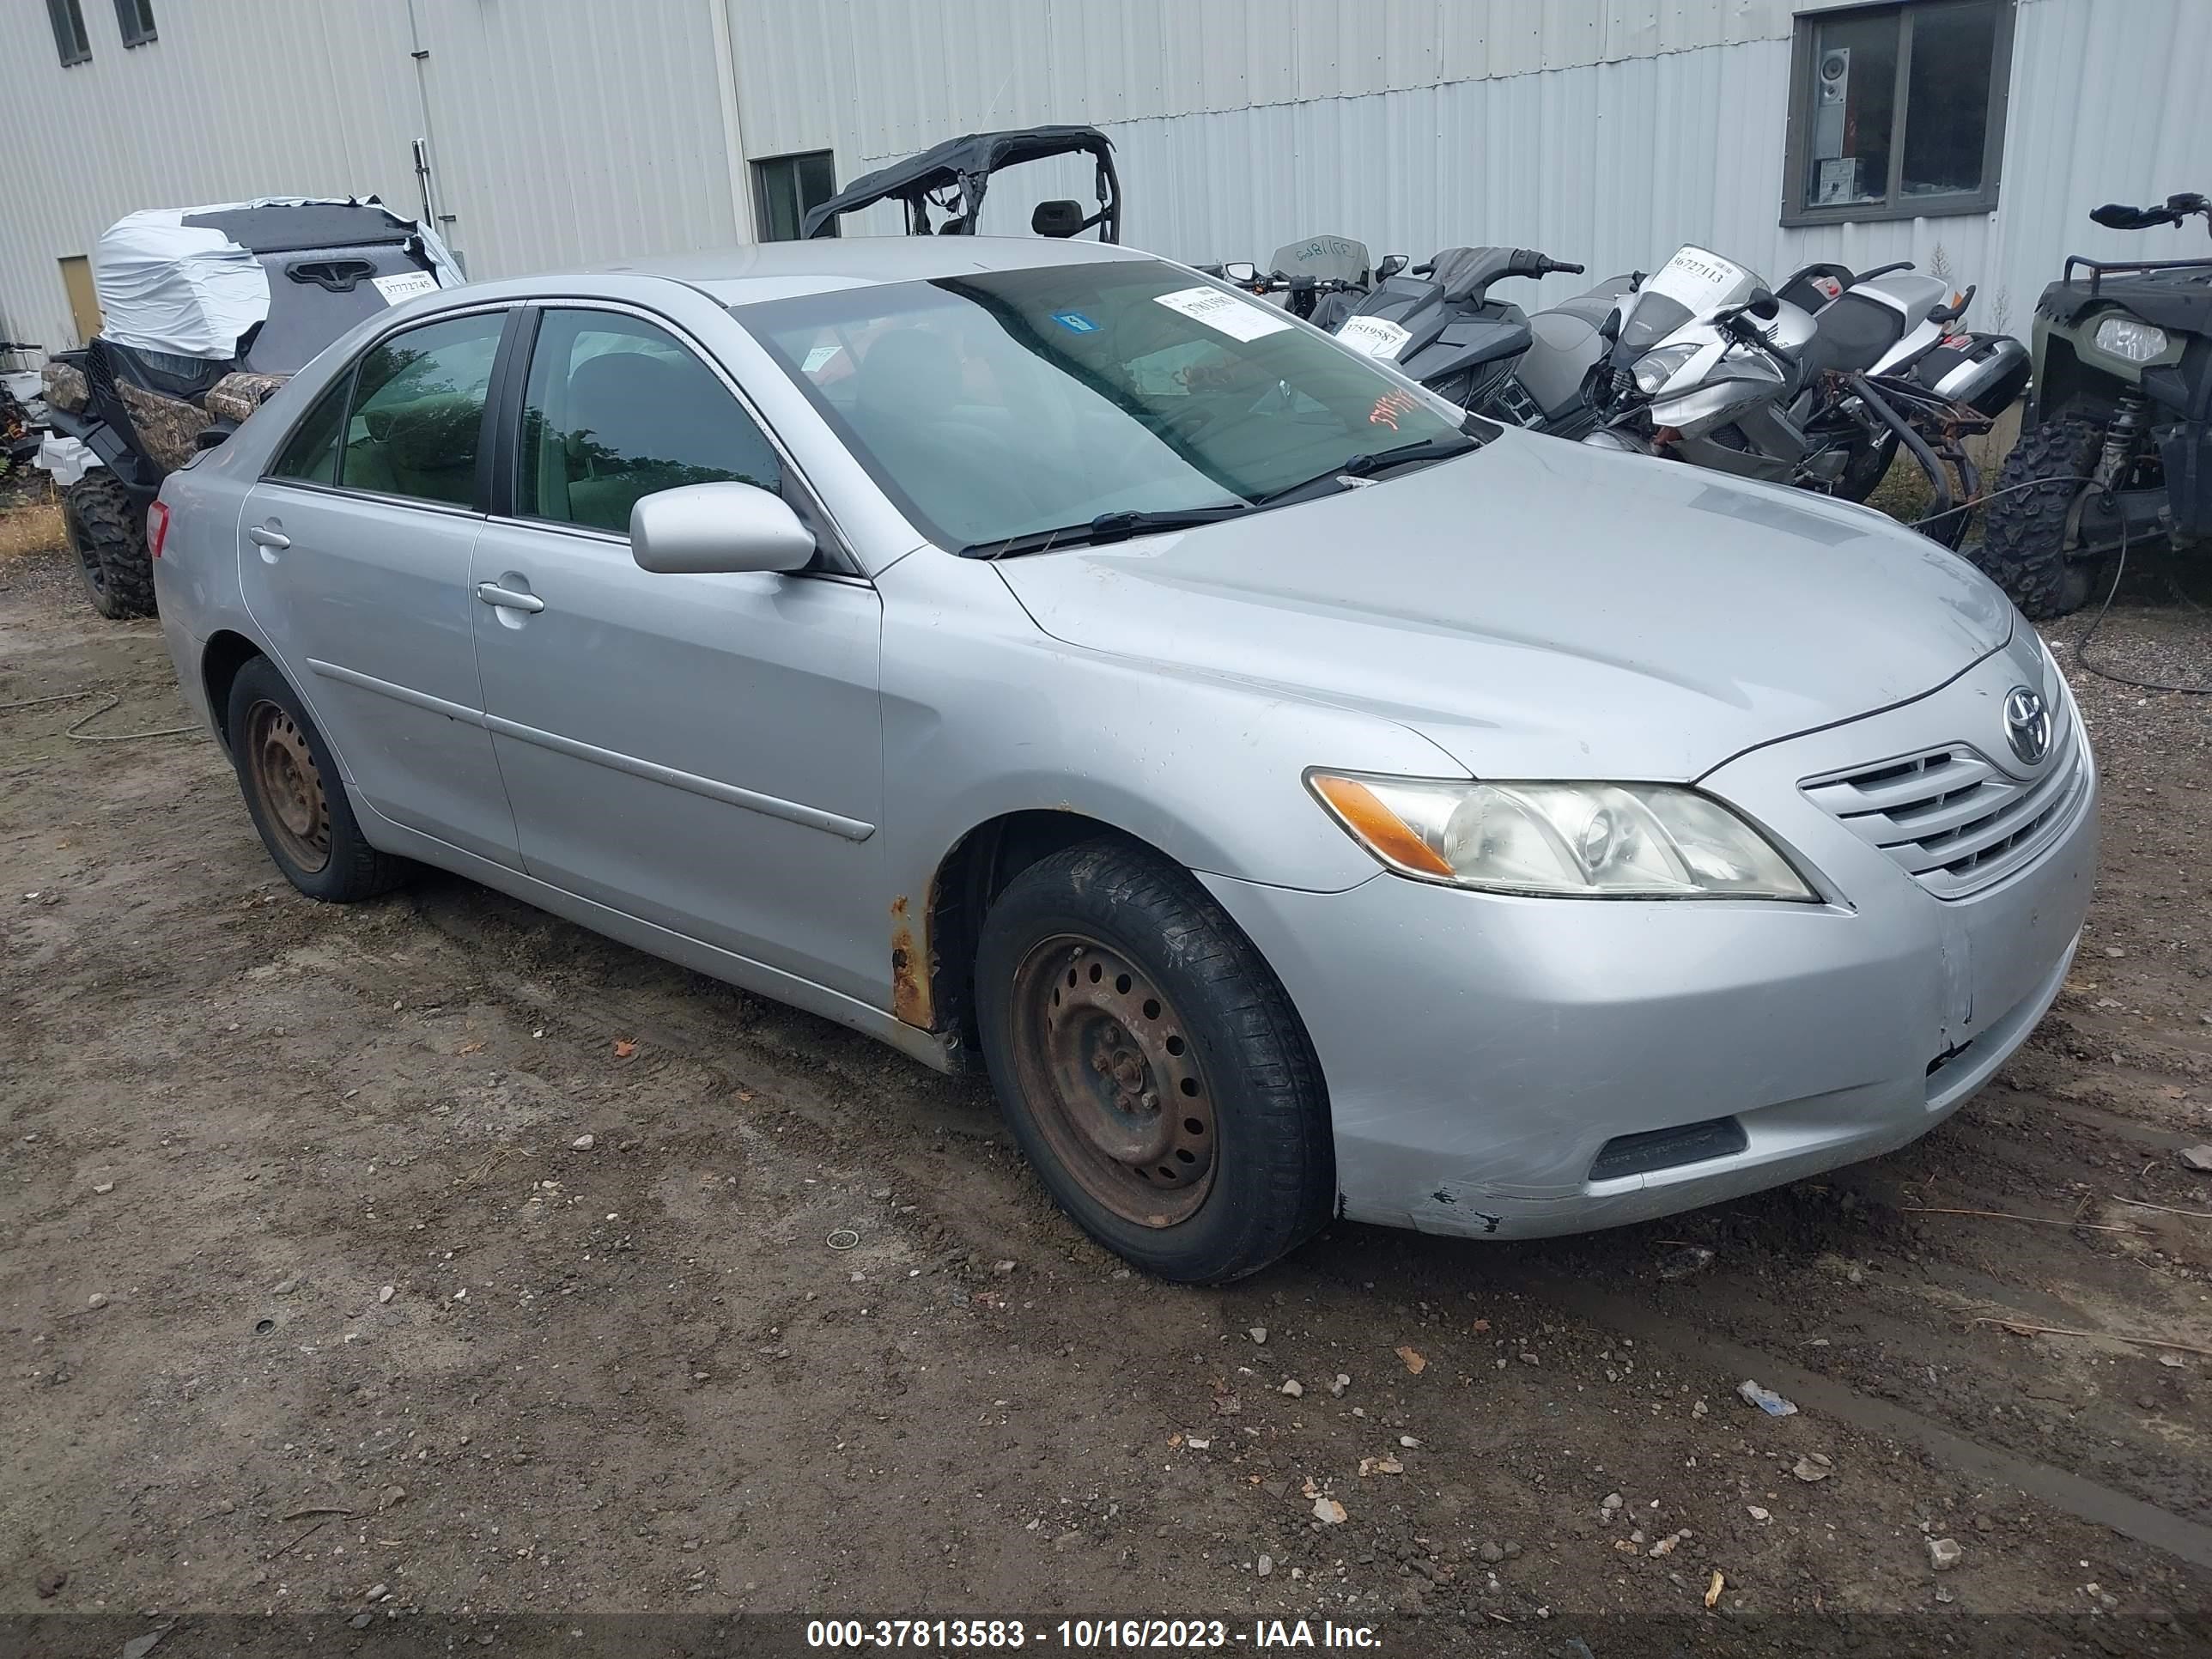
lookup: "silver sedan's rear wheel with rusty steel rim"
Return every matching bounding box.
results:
[223,657,414,905]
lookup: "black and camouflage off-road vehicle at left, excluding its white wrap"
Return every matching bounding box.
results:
[45,197,458,617]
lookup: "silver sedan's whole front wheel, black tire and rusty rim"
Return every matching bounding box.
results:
[975,841,1336,1283]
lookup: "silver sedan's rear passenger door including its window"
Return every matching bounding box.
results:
[239,307,520,867]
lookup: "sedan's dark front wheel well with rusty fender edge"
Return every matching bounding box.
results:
[911,810,1168,1053]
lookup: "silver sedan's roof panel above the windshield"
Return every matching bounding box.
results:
[602,237,1152,305]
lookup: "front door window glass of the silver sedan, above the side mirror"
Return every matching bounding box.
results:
[515,310,783,535]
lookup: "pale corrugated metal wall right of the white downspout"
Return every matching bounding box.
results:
[730,0,2212,331]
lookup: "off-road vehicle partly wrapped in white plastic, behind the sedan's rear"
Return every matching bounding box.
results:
[42,197,462,617]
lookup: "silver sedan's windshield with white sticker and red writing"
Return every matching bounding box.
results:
[732,261,1474,550]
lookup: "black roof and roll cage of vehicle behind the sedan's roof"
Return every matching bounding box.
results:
[803,126,1121,241]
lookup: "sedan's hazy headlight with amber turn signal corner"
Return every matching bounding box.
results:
[1305,772,1818,902]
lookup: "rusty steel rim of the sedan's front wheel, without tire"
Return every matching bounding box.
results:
[1013,933,1218,1228]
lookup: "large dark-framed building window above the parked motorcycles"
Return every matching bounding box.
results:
[1783,0,2013,226]
